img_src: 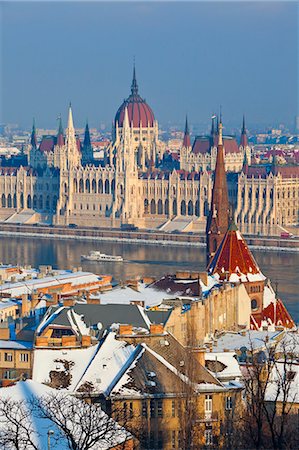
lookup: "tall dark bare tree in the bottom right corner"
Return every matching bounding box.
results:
[240,333,299,450]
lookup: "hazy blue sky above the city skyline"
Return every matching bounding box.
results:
[0,1,298,128]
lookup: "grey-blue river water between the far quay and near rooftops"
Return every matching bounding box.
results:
[0,237,299,323]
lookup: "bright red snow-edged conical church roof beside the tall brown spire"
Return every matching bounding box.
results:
[208,223,263,282]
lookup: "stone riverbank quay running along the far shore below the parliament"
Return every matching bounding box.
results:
[0,224,299,252]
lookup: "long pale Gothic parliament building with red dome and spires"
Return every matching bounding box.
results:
[0,68,299,234]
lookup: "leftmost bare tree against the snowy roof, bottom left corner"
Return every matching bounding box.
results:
[0,398,40,450]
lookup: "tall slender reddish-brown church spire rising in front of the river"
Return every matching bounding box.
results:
[206,121,229,263]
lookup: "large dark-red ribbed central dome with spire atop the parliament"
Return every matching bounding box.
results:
[115,67,155,128]
